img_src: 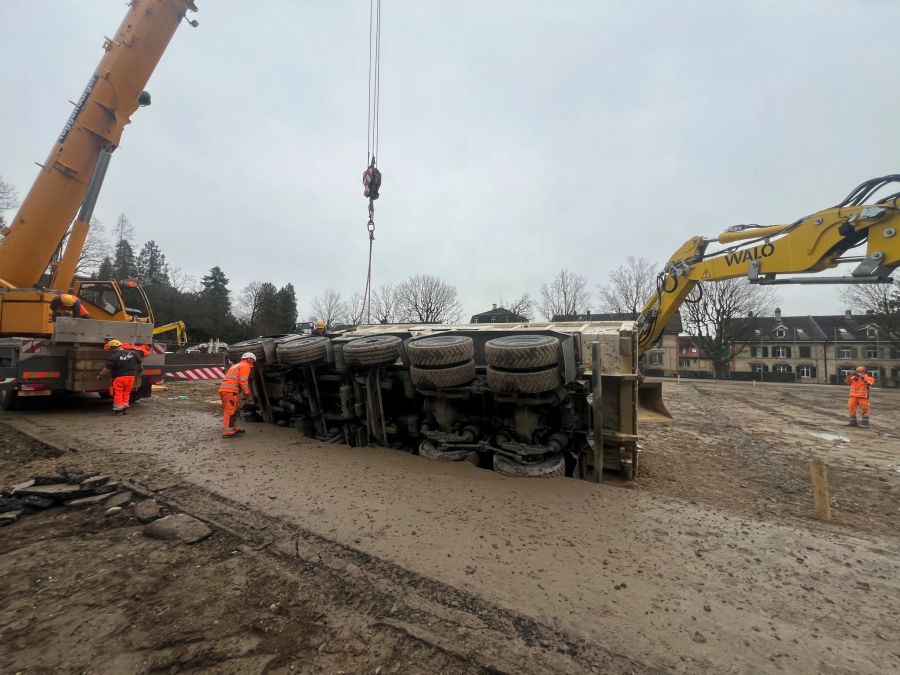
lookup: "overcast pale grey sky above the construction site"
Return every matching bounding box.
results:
[0,0,900,316]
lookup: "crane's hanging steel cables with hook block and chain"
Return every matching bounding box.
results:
[363,0,381,323]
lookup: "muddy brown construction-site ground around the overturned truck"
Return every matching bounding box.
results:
[0,382,900,673]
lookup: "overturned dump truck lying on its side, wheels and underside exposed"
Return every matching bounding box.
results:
[229,321,639,480]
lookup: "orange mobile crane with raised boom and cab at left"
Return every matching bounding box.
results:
[0,0,197,407]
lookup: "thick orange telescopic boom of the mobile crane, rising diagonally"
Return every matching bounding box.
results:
[0,0,197,288]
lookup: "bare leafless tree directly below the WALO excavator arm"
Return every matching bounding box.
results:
[681,279,778,379]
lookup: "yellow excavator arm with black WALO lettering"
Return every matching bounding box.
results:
[637,174,900,354]
